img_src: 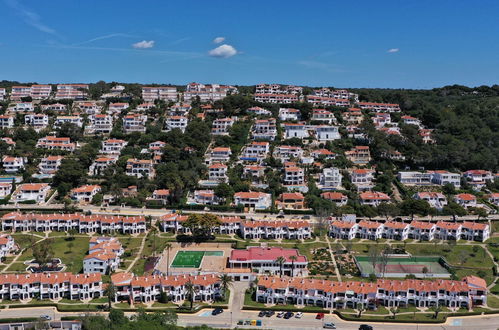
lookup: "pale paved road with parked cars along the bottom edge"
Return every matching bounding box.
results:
[0,307,499,330]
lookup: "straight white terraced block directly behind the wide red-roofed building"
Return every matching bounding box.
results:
[240,220,313,240]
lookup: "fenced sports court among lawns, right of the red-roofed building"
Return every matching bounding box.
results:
[355,256,450,278]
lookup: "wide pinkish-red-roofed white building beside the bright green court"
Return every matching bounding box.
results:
[228,247,308,277]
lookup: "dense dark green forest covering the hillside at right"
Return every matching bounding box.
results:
[352,85,499,170]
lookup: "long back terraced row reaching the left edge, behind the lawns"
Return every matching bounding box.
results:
[1,212,146,234]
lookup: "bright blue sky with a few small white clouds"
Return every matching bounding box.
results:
[0,0,499,88]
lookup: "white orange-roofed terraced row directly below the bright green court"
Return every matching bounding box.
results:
[111,273,221,302]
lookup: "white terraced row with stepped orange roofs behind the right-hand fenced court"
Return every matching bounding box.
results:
[329,220,490,242]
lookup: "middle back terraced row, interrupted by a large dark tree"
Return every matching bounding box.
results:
[160,213,313,239]
